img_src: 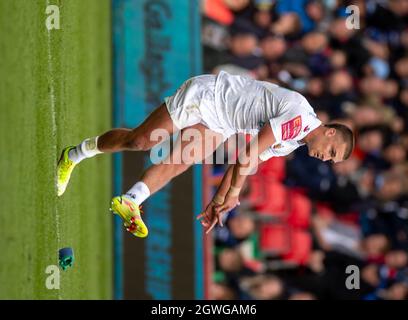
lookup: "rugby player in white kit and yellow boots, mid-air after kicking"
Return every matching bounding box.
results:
[57,72,354,237]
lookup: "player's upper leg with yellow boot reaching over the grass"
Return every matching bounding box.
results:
[57,103,175,196]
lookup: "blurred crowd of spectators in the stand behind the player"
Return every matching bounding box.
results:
[202,0,408,300]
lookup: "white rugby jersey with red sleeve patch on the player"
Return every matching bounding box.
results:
[215,71,321,161]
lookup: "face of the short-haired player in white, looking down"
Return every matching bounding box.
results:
[308,129,346,163]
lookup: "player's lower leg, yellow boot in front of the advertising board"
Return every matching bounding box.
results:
[112,124,224,237]
